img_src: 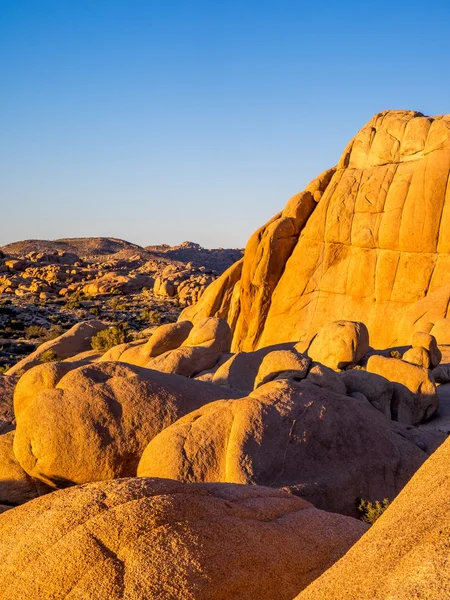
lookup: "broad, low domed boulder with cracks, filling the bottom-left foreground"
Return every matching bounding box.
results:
[0,478,367,600]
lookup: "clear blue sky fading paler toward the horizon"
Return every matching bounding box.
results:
[0,0,450,247]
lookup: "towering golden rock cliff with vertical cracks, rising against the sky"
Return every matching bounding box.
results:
[182,111,450,350]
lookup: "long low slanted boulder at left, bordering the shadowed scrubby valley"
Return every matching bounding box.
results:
[8,319,107,375]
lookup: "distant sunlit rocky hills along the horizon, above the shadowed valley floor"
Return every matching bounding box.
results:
[0,238,242,305]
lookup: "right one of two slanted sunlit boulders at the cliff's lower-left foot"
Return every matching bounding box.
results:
[146,317,232,377]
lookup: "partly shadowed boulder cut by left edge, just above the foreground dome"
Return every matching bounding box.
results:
[0,431,51,507]
